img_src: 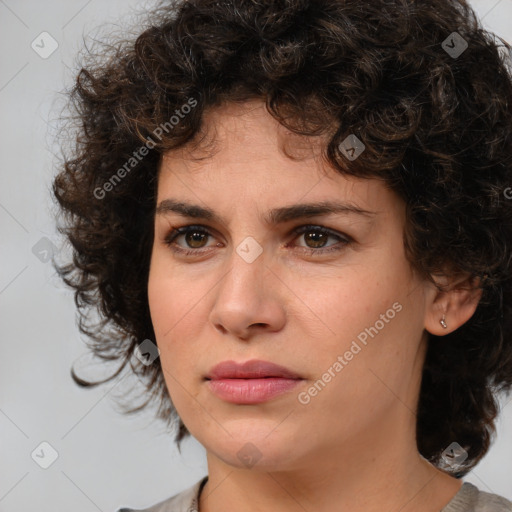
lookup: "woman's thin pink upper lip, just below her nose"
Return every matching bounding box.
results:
[206,359,302,380]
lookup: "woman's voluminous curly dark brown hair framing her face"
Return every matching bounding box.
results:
[52,0,512,478]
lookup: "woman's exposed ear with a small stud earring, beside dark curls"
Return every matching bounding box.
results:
[425,275,483,336]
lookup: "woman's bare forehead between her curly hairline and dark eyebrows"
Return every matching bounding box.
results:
[158,101,404,221]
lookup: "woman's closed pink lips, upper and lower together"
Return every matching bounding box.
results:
[206,359,303,405]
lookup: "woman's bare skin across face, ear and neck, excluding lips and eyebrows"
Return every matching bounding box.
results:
[148,100,480,512]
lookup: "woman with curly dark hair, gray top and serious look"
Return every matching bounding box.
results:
[53,0,512,512]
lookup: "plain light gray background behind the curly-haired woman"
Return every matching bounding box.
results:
[0,0,512,512]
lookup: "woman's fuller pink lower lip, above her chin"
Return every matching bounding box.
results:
[208,377,302,404]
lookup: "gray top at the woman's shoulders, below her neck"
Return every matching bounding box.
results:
[116,476,512,512]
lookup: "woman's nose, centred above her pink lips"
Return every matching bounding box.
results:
[209,243,287,340]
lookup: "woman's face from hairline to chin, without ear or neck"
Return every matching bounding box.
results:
[148,101,432,469]
